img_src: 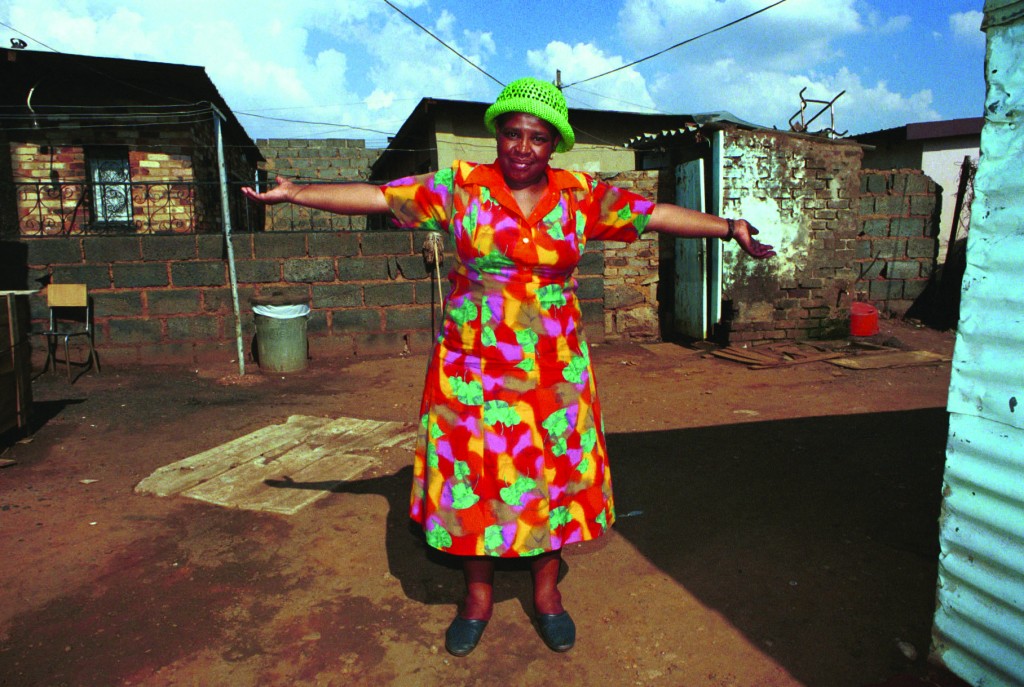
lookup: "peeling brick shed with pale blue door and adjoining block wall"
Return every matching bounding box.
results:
[630,120,938,344]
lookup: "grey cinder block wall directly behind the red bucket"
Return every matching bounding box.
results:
[856,169,941,315]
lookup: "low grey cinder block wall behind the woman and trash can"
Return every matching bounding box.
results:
[18,231,604,363]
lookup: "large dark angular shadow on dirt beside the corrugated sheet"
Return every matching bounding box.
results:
[608,409,948,685]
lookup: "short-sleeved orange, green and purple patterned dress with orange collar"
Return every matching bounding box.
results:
[382,162,654,558]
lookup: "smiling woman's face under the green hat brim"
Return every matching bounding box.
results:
[496,113,558,190]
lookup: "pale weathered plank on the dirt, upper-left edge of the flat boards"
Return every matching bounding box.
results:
[135,416,331,497]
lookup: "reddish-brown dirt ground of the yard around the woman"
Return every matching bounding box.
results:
[0,320,970,687]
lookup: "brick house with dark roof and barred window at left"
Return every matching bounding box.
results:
[0,49,262,238]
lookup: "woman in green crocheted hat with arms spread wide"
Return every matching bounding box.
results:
[244,78,774,656]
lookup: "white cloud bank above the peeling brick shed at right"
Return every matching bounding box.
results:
[614,0,939,133]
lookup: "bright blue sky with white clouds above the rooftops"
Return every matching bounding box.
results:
[0,0,984,146]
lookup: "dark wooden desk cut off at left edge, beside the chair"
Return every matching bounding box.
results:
[0,291,36,432]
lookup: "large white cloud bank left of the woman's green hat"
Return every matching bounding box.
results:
[0,0,497,144]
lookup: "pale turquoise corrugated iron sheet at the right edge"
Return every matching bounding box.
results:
[932,5,1024,687]
